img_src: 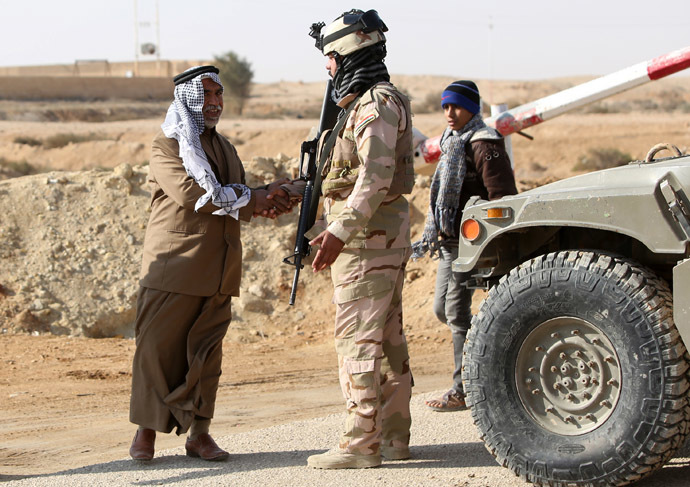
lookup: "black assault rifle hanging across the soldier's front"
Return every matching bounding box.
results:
[283,80,341,305]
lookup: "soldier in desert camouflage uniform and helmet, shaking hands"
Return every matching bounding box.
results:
[308,10,414,468]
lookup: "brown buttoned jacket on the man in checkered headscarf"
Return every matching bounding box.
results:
[140,130,256,296]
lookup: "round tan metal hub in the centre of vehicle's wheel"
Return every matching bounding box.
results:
[515,317,621,435]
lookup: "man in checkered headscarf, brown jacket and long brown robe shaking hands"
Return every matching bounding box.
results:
[130,66,290,460]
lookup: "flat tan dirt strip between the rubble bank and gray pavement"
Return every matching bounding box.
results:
[0,327,451,476]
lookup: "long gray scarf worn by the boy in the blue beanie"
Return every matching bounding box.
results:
[412,112,486,258]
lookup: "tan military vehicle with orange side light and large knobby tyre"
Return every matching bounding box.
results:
[453,144,690,487]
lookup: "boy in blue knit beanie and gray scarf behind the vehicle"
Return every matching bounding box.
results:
[413,80,517,412]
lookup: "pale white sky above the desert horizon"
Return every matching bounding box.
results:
[0,0,690,83]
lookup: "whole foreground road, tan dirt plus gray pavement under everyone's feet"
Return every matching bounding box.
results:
[0,330,690,487]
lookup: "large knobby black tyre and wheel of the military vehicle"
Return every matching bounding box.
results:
[462,251,690,487]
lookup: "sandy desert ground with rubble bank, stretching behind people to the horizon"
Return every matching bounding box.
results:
[0,72,690,485]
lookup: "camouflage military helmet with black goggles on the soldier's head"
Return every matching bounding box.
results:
[309,10,388,56]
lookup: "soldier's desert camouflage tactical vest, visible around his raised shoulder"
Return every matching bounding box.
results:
[321,83,414,196]
